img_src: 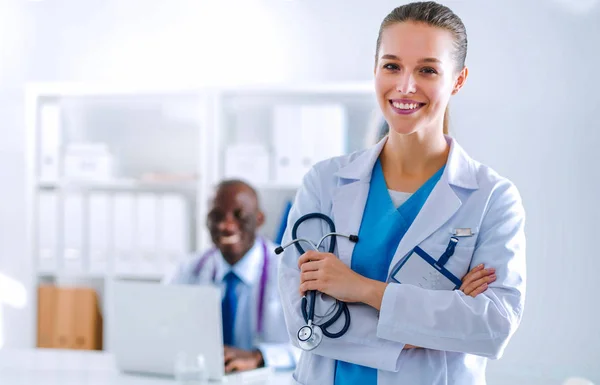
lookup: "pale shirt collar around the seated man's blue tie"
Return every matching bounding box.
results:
[215,237,263,286]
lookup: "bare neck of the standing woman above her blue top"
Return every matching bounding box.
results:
[380,131,450,192]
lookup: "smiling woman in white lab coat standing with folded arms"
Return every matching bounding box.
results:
[279,2,525,385]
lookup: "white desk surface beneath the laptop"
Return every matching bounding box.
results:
[0,349,292,385]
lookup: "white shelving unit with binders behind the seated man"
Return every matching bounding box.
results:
[25,82,376,351]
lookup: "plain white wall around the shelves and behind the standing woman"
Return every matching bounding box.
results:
[0,0,600,382]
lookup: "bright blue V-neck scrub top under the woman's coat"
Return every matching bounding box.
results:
[334,159,445,385]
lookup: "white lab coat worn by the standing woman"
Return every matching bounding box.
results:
[279,137,525,385]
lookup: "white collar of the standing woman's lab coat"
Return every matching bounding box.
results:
[335,135,479,190]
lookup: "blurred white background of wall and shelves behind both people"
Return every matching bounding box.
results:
[0,0,600,383]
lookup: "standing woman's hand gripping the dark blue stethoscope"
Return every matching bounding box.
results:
[298,250,367,302]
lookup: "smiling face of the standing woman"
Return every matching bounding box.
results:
[375,21,467,135]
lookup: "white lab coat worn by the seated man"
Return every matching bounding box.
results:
[163,239,299,370]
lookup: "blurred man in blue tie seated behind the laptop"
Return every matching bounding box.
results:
[166,180,297,372]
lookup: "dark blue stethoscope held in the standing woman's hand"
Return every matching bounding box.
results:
[275,213,358,351]
